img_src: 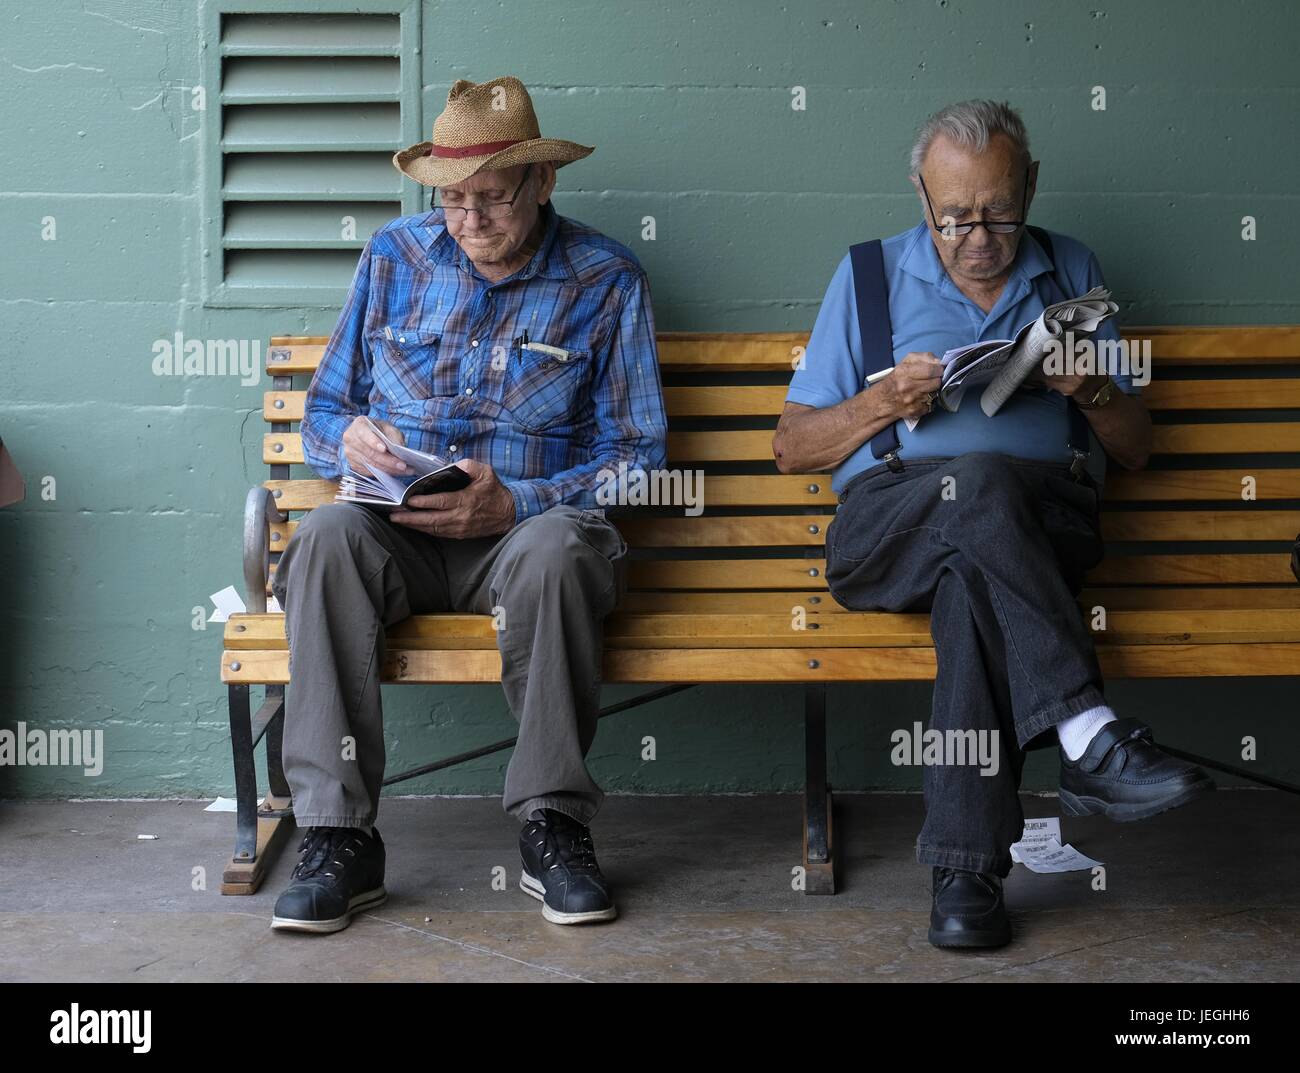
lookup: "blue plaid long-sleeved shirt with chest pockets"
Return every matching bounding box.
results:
[302,203,667,523]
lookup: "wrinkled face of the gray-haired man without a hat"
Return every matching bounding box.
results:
[915,134,1037,282]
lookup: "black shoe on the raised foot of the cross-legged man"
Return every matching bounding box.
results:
[1061,719,1214,822]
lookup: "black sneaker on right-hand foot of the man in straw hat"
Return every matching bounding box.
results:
[519,809,618,923]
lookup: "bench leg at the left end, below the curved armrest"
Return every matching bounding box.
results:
[221,685,294,895]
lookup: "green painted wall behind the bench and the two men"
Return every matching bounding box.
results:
[0,0,1300,797]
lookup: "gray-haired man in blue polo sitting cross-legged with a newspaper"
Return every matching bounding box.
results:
[774,100,1214,947]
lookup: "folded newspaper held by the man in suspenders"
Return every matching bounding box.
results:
[906,287,1119,431]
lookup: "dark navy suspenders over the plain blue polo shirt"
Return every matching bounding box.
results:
[849,225,1089,480]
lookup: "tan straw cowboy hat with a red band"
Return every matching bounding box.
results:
[393,75,594,186]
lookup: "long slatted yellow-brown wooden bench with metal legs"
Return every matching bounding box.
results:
[221,326,1300,894]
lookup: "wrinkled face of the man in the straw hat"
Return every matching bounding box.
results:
[438,164,555,264]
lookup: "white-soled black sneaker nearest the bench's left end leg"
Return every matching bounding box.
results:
[270,827,389,931]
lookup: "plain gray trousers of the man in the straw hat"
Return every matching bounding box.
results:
[272,503,628,827]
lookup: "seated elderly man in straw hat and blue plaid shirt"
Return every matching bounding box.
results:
[273,78,666,933]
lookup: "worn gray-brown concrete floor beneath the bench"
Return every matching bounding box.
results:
[0,789,1300,982]
